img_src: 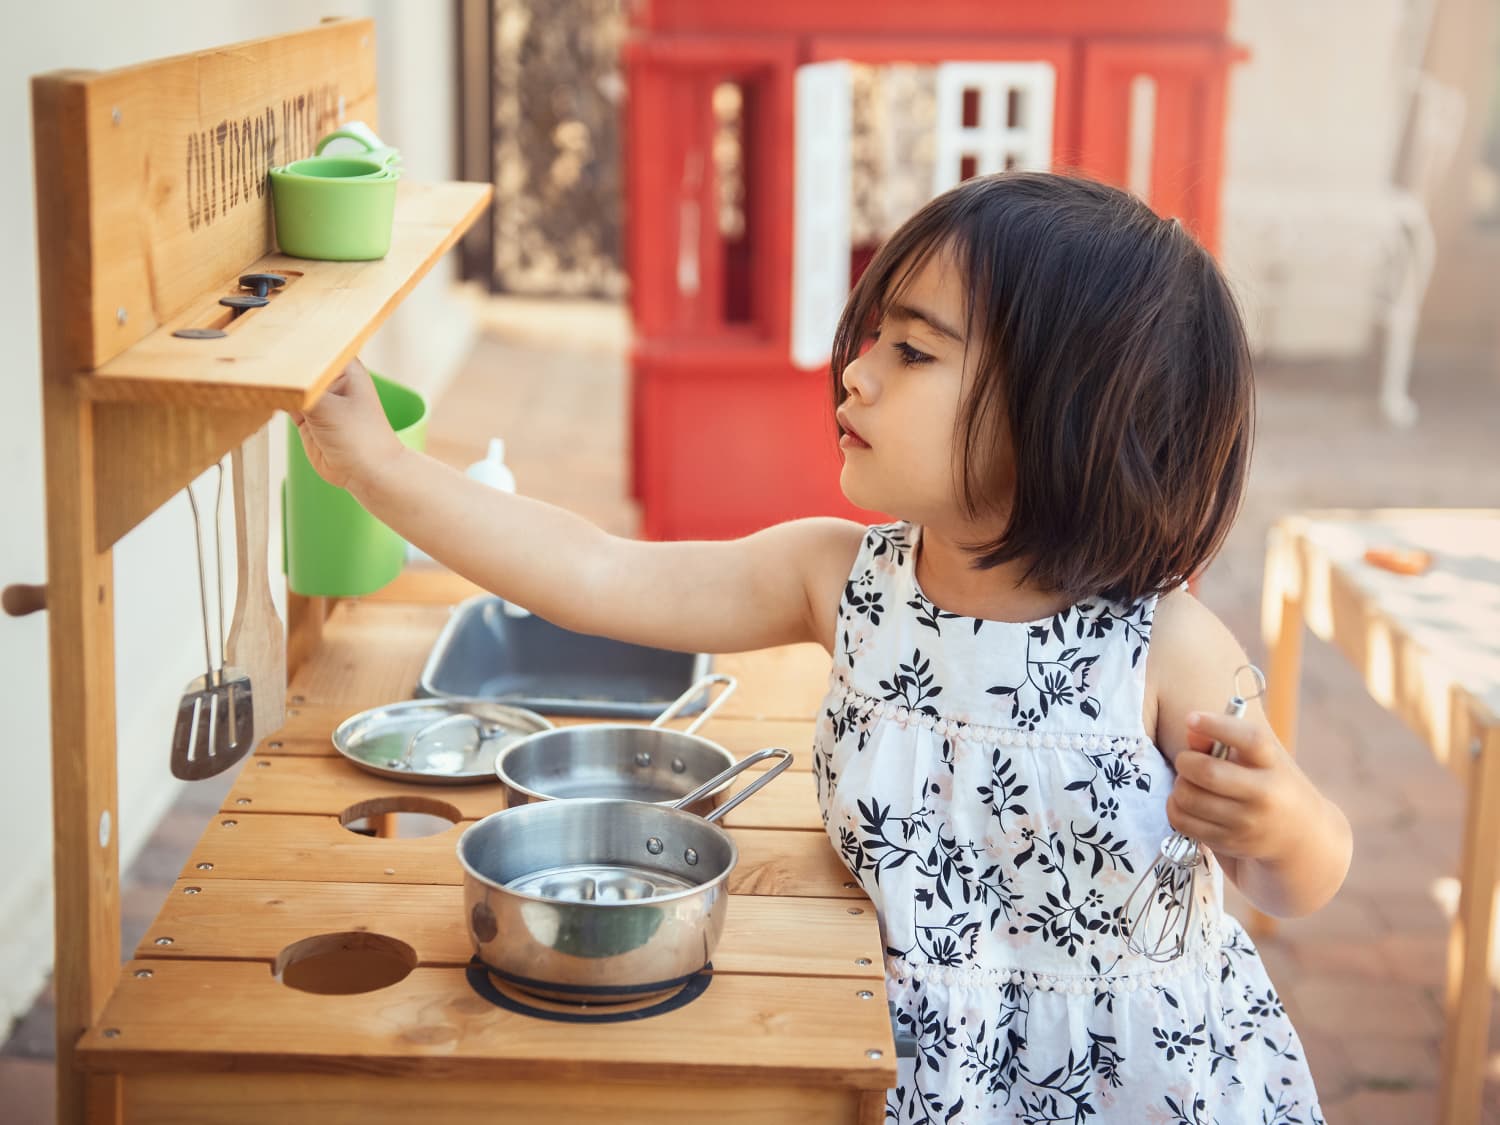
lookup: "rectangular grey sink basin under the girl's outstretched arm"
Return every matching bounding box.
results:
[417,596,713,719]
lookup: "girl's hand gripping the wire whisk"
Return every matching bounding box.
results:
[1167,711,1323,861]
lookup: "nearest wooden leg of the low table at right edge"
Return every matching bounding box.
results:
[1439,728,1500,1125]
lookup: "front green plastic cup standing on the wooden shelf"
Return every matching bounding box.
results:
[270,156,401,261]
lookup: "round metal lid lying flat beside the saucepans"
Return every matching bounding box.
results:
[333,699,552,785]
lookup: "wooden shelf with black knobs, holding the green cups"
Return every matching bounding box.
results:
[83,183,492,411]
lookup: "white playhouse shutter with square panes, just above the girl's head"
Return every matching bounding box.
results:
[933,63,1058,194]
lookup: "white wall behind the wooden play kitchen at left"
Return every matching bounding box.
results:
[0,0,473,1032]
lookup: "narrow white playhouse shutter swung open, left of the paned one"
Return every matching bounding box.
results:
[792,62,852,371]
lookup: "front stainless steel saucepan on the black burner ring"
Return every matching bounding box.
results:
[458,749,792,1004]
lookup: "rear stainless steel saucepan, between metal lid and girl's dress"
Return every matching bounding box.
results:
[495,675,735,815]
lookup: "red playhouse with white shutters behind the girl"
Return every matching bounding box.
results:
[626,0,1238,539]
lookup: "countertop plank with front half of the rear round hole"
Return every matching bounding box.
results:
[182,822,863,899]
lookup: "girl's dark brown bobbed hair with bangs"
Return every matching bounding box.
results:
[833,173,1254,602]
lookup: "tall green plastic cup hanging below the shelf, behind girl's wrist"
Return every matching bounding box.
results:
[282,372,428,597]
